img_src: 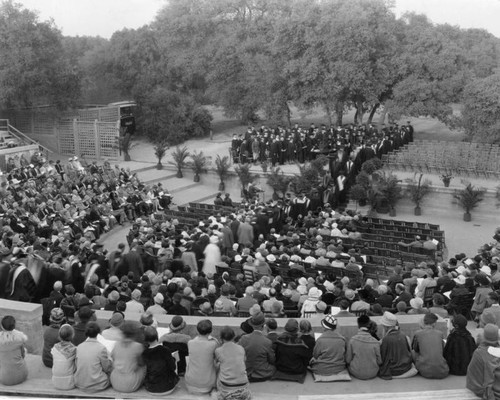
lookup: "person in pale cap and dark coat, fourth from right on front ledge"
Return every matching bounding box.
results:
[379,311,418,380]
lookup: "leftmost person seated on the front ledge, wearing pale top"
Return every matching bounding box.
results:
[0,315,28,386]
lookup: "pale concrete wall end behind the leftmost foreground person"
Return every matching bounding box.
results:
[0,299,43,354]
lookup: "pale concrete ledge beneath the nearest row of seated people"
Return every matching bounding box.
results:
[0,354,468,400]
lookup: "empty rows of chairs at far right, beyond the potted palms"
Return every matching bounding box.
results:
[382,140,500,178]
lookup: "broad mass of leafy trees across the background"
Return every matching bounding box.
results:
[0,0,500,142]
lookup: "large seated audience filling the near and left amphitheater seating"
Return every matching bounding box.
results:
[0,143,500,398]
